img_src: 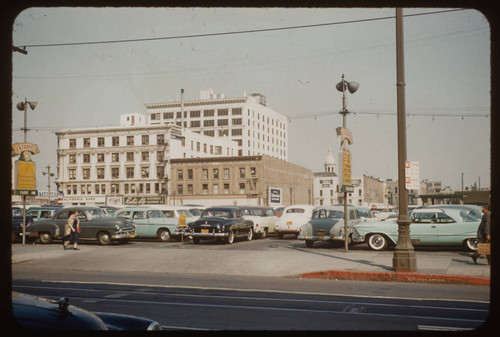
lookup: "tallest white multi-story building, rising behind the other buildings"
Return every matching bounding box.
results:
[145,89,288,161]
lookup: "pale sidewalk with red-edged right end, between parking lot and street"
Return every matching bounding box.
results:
[12,243,491,286]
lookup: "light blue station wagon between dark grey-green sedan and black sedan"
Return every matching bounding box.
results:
[114,207,178,242]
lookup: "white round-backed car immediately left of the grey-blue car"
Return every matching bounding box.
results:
[274,205,314,239]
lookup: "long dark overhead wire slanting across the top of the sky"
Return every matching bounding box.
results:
[14,8,467,49]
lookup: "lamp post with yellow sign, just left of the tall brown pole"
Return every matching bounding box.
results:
[336,74,359,252]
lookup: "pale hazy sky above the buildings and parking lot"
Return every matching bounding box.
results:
[12,7,491,190]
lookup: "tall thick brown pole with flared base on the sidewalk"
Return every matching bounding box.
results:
[392,8,417,272]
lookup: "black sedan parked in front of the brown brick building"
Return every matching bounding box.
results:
[180,206,253,244]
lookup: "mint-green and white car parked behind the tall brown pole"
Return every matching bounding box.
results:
[352,206,481,251]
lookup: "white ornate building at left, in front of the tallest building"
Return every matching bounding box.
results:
[56,114,238,205]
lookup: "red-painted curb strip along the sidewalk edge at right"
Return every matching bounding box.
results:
[299,270,490,286]
